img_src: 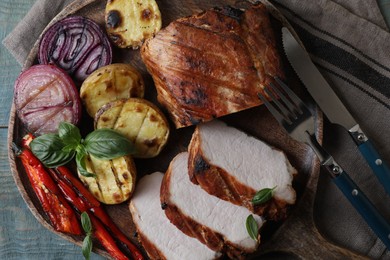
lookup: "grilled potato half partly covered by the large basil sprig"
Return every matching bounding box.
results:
[79,155,136,204]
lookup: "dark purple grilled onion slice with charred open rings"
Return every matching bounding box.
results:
[38,16,112,82]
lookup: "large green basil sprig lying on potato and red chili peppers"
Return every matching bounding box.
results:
[30,122,134,177]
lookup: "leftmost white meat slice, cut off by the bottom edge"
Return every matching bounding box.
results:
[130,172,220,260]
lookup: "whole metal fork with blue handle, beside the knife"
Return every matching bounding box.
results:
[258,78,390,250]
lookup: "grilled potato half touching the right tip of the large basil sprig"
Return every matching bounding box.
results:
[95,98,169,158]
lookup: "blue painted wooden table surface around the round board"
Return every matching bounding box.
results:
[0,0,390,260]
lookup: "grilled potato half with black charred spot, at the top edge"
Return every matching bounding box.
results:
[105,0,161,49]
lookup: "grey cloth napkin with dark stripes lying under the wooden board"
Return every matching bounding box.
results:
[3,0,390,259]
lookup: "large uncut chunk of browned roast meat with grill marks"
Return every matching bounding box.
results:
[141,4,283,128]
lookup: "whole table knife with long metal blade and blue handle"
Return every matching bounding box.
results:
[282,27,390,195]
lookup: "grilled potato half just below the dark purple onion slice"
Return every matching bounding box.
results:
[80,63,145,117]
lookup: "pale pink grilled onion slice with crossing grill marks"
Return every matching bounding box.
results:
[14,65,81,135]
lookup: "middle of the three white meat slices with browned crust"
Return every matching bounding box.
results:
[161,152,262,258]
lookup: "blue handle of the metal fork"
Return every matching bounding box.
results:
[333,171,390,250]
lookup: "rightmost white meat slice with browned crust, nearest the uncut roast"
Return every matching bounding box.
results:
[188,120,297,220]
